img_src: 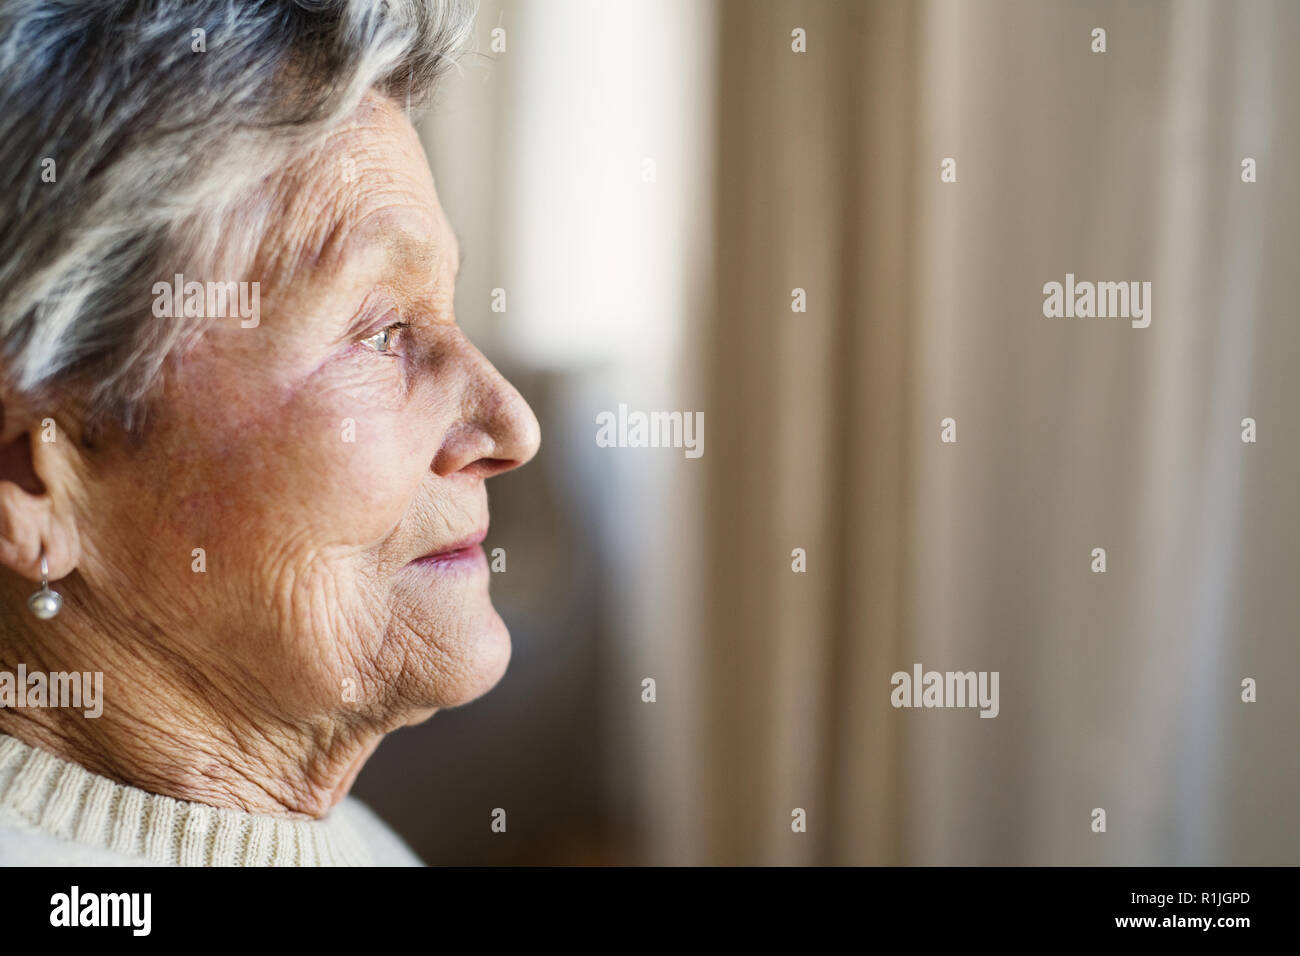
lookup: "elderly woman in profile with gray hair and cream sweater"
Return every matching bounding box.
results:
[0,0,538,865]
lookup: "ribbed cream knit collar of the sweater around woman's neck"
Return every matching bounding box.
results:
[0,734,373,866]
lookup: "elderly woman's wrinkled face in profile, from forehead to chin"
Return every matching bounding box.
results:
[78,96,540,731]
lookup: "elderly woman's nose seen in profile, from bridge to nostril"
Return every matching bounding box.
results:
[433,338,542,479]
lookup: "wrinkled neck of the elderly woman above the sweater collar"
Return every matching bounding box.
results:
[0,613,382,819]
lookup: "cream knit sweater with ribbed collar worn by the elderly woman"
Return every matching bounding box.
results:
[0,734,423,866]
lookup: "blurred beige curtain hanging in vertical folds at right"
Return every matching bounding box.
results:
[670,0,1300,864]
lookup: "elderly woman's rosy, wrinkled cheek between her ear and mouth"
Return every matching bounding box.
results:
[152,389,432,711]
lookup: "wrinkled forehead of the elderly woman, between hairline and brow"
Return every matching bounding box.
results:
[259,94,459,287]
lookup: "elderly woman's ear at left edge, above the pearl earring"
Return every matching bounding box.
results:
[0,402,81,581]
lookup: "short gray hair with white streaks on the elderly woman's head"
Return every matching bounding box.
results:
[0,0,475,428]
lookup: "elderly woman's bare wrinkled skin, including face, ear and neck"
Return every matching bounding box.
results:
[0,95,540,817]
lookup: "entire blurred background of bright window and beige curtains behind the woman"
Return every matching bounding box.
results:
[355,0,1300,865]
